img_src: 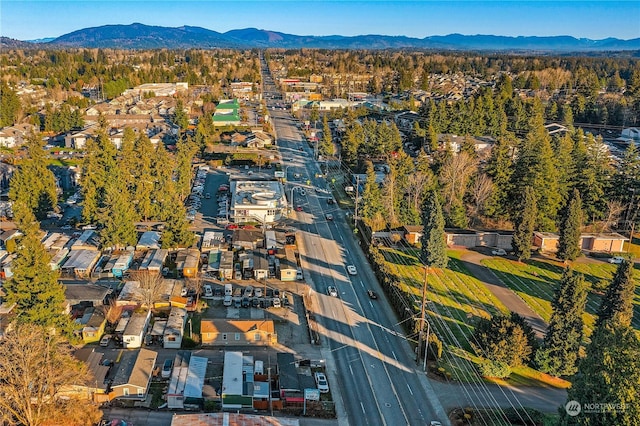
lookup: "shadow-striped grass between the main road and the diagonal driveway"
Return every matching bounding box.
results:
[382,248,568,387]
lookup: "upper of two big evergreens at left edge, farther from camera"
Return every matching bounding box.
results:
[9,134,58,219]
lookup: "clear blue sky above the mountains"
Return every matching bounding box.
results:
[0,0,640,40]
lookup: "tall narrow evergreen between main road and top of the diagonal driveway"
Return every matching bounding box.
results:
[420,190,449,268]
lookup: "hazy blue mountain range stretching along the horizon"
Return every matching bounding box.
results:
[1,23,640,52]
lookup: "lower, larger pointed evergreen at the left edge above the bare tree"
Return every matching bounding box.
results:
[4,211,72,335]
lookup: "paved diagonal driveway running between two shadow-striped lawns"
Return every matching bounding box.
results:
[462,251,547,339]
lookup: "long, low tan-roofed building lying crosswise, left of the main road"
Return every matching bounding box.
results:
[200,319,278,346]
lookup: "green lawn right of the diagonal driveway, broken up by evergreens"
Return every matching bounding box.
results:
[482,258,640,335]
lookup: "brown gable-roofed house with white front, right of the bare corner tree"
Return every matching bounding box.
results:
[110,349,158,401]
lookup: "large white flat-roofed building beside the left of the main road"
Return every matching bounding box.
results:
[229,180,287,223]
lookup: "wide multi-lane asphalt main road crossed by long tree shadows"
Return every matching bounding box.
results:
[272,111,446,425]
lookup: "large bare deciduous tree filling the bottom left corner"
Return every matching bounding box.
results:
[0,324,102,426]
